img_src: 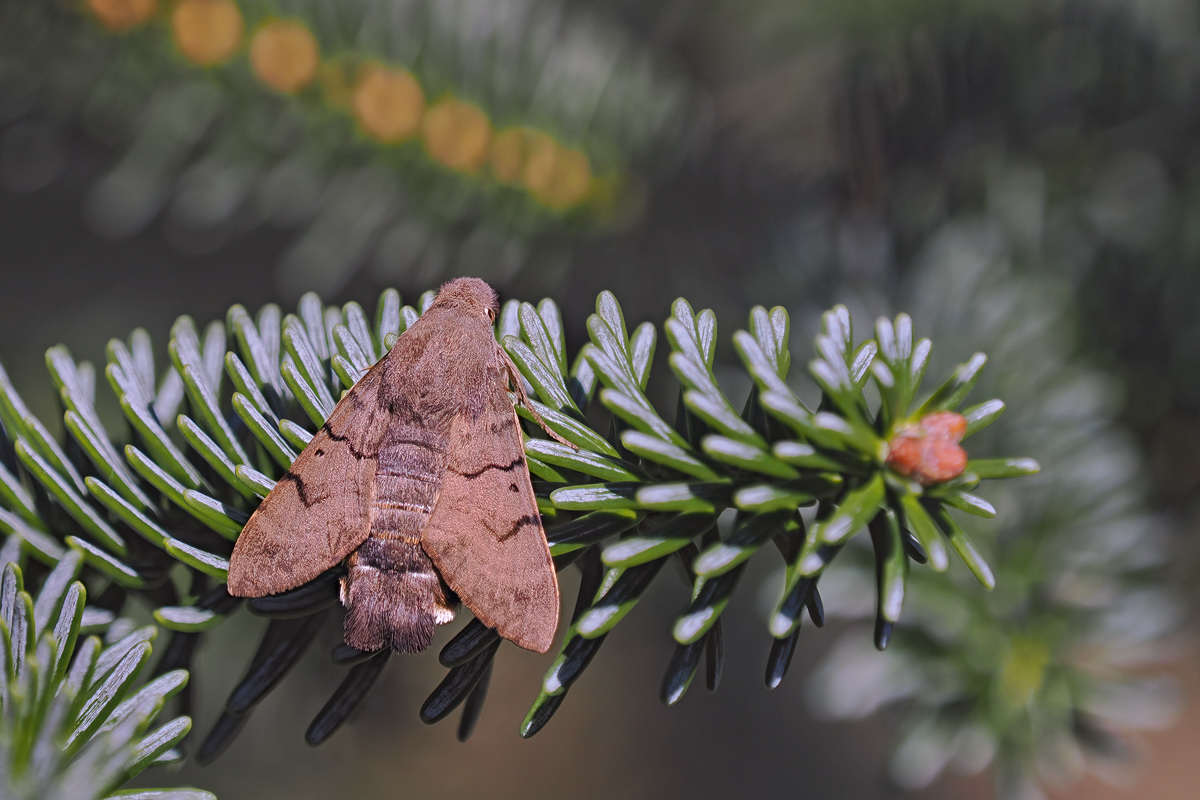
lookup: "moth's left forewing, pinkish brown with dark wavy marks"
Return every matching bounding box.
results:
[229,359,388,597]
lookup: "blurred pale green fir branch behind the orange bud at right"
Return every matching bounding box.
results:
[808,221,1181,800]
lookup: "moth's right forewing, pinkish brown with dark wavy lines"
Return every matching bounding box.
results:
[421,364,558,652]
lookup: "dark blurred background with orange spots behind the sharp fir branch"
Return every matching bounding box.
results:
[0,0,1200,800]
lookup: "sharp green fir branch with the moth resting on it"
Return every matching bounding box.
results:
[0,283,1037,762]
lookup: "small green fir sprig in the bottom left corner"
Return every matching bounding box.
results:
[0,546,206,800]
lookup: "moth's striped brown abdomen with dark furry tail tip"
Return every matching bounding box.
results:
[342,429,458,652]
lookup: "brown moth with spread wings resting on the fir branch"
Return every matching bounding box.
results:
[229,278,558,652]
